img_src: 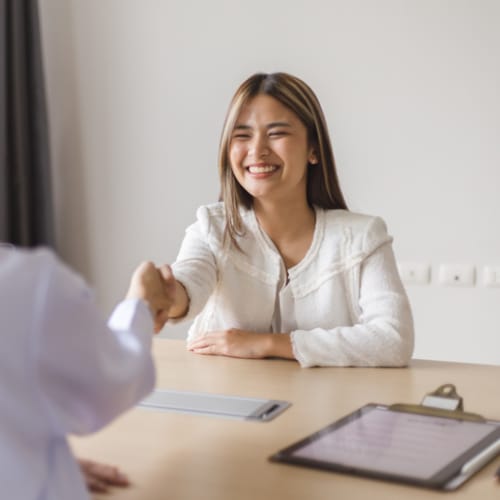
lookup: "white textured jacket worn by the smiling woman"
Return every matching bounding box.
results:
[172,203,413,367]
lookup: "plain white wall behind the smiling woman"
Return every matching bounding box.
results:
[40,0,500,364]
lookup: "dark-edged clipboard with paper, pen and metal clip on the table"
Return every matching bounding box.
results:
[269,384,500,490]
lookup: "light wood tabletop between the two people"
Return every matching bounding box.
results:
[71,339,500,500]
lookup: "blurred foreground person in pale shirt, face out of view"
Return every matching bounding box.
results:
[0,246,170,500]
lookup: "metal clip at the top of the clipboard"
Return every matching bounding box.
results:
[390,384,485,422]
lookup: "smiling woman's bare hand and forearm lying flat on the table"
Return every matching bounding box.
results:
[187,328,295,359]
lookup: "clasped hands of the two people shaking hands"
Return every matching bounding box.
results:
[126,262,189,333]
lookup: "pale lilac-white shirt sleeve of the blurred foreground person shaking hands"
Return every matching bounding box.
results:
[32,254,155,434]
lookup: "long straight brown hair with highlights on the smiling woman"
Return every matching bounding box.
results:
[219,73,347,248]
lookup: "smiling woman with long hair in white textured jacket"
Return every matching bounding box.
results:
[160,73,414,367]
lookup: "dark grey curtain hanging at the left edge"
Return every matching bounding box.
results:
[0,0,54,247]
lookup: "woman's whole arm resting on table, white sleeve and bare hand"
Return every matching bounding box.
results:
[188,243,413,367]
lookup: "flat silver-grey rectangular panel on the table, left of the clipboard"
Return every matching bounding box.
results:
[138,389,290,422]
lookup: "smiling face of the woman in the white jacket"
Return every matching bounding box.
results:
[229,94,317,202]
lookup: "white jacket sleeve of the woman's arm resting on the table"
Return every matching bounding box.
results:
[291,227,414,367]
